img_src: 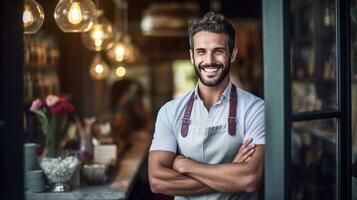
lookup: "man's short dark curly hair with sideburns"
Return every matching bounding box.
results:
[188,11,236,53]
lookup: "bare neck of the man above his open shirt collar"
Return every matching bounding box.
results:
[198,78,229,110]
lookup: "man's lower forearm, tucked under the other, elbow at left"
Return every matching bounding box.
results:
[149,167,212,196]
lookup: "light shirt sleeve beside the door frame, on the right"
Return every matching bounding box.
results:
[244,100,265,144]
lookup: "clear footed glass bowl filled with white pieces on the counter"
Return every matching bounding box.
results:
[39,150,80,192]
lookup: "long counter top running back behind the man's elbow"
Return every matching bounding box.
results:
[25,134,151,200]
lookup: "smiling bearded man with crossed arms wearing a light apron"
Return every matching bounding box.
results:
[149,12,265,199]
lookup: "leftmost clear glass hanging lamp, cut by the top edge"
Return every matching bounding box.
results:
[22,0,45,34]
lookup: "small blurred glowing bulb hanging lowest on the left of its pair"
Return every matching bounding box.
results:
[89,54,110,80]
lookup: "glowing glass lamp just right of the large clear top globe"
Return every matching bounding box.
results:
[82,10,114,51]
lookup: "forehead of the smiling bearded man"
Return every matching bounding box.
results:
[193,31,228,49]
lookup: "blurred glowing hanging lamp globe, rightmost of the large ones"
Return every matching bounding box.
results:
[107,35,135,63]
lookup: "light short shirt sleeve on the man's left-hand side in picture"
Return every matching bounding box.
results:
[150,104,177,153]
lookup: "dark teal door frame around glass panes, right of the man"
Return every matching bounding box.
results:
[262,0,352,200]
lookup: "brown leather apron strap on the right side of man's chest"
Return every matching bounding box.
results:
[228,84,238,136]
